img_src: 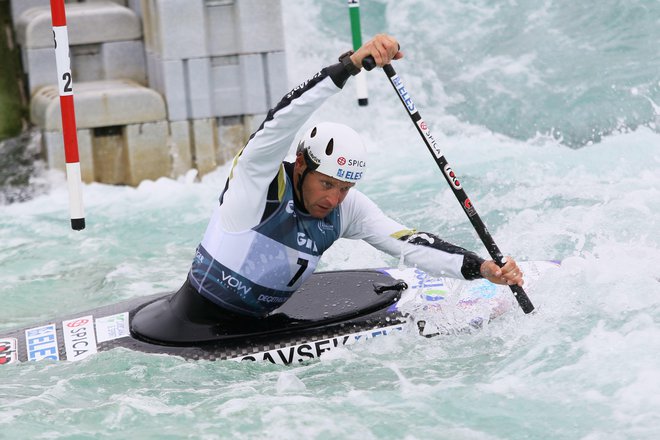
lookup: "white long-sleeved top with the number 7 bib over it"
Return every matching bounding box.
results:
[189,64,483,316]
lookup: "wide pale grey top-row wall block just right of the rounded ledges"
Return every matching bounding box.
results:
[149,0,207,60]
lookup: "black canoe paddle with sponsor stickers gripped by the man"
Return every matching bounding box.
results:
[362,56,534,313]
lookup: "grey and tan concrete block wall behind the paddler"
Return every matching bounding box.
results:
[11,0,287,185]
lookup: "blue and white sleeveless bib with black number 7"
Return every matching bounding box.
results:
[189,172,340,316]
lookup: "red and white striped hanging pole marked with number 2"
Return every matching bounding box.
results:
[50,0,85,231]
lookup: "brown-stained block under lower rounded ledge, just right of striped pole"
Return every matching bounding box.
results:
[92,126,128,185]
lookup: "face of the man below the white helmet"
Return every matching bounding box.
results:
[296,165,355,218]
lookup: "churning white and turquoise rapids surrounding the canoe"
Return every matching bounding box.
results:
[0,0,660,440]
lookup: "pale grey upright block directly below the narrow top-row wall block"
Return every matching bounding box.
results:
[211,56,244,116]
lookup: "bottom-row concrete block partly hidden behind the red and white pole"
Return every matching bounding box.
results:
[41,129,94,183]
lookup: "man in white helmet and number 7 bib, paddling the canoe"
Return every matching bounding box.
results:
[183,35,523,322]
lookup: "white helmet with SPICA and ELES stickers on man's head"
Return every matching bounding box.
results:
[296,122,367,183]
